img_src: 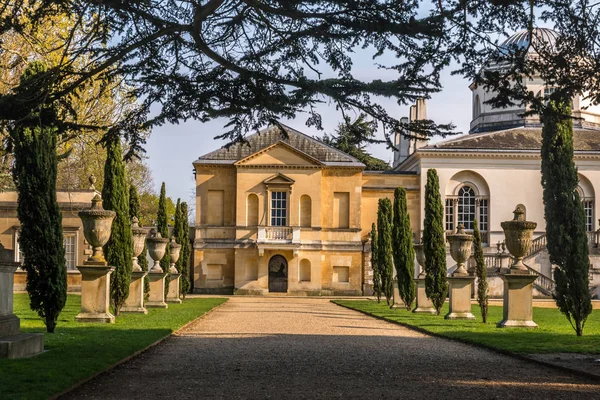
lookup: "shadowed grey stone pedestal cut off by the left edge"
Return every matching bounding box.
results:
[0,261,44,358]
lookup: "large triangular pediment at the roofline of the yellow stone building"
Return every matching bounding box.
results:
[235,142,323,167]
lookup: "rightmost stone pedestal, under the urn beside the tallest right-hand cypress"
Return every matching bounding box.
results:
[498,274,537,328]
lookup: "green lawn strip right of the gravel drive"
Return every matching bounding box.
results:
[333,300,600,354]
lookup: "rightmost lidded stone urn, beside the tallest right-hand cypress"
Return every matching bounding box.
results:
[500,206,537,274]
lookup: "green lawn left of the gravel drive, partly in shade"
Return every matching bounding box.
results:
[0,294,227,399]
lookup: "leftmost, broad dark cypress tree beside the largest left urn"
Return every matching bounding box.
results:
[9,62,67,333]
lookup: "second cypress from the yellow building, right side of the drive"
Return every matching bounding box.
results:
[377,199,394,306]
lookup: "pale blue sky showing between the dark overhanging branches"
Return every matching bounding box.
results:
[145,62,471,206]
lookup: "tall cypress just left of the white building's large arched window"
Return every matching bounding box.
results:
[423,169,448,315]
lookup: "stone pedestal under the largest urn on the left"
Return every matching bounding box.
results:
[75,263,115,323]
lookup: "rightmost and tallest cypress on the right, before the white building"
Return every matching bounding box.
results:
[542,99,592,336]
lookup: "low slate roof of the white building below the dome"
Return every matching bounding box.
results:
[421,127,600,151]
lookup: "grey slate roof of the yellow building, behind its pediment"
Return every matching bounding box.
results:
[194,124,364,167]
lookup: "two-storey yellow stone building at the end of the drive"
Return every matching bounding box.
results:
[192,126,420,295]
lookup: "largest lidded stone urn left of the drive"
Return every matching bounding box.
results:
[78,194,117,265]
